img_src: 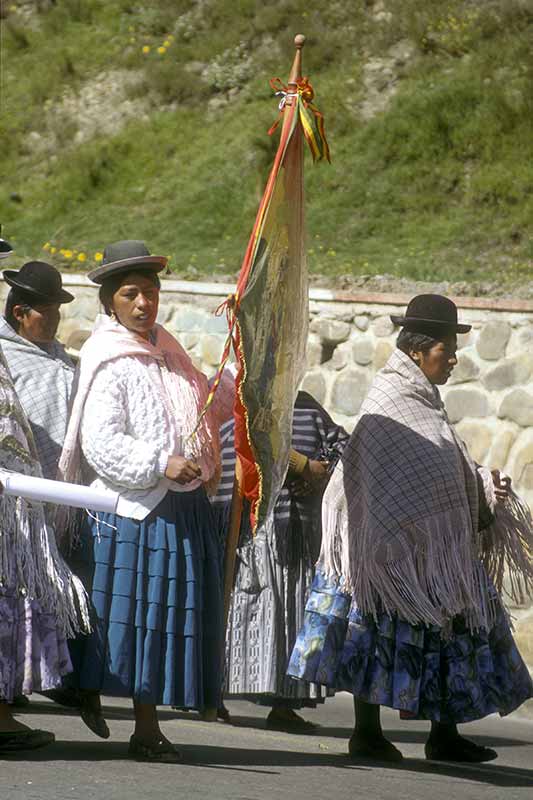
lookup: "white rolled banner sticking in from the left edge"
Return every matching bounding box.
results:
[0,470,119,514]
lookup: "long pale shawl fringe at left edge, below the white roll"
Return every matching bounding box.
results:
[0,496,91,638]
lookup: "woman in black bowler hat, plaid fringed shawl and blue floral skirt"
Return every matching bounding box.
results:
[289,294,533,762]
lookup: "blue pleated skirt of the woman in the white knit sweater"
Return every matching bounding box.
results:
[78,488,223,709]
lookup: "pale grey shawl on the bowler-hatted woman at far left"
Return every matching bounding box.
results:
[0,317,74,479]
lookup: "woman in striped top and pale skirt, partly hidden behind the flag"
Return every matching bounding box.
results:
[213,392,348,733]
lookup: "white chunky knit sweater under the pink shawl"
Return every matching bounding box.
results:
[80,356,206,519]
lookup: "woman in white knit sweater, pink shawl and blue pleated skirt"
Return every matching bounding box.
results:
[60,241,229,761]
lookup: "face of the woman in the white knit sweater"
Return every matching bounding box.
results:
[111,272,159,339]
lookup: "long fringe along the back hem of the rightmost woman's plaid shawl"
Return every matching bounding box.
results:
[319,462,494,631]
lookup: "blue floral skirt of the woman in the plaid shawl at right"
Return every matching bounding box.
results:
[288,572,533,723]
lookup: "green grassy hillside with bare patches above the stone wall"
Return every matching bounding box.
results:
[0,0,533,292]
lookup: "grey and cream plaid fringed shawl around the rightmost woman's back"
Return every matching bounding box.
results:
[319,350,502,628]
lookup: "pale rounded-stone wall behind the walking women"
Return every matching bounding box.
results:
[0,276,533,665]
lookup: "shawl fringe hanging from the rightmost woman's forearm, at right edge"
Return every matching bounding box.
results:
[481,491,533,605]
